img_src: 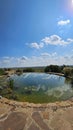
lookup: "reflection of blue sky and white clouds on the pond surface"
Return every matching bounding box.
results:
[10,73,73,99]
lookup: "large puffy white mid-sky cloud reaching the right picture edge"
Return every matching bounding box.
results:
[42,35,73,46]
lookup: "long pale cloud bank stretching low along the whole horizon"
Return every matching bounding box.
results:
[0,52,73,67]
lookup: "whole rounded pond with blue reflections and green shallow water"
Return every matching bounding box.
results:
[9,73,73,103]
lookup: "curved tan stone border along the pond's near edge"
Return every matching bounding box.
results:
[0,98,73,111]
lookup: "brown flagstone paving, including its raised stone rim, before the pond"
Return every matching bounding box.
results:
[0,98,73,130]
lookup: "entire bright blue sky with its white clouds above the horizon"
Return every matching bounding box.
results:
[0,0,73,67]
